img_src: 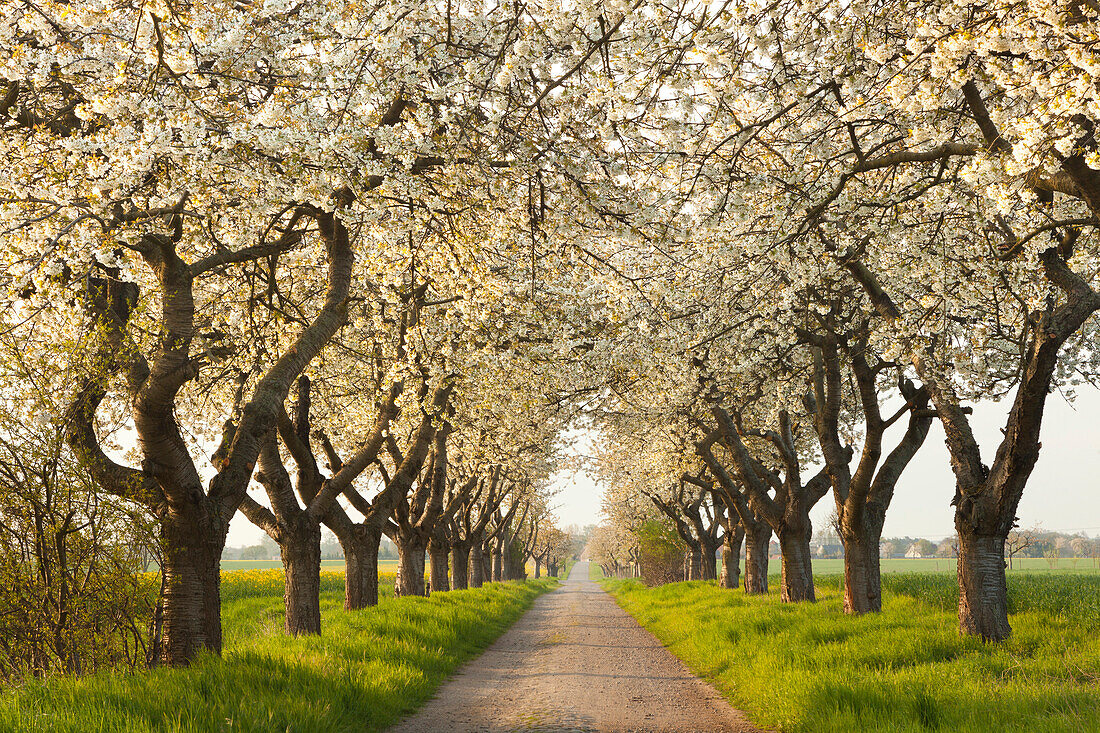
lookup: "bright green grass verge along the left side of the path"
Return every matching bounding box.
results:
[0,570,558,733]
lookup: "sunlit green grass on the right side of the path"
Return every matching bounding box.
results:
[604,573,1100,733]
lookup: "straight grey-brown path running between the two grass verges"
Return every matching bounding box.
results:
[391,562,757,733]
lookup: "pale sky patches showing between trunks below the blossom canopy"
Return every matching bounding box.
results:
[229,389,1100,546]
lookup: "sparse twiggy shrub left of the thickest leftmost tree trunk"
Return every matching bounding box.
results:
[0,422,155,682]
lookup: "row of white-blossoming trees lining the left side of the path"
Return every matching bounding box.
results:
[0,0,605,664]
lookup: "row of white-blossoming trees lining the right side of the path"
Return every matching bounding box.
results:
[576,0,1100,641]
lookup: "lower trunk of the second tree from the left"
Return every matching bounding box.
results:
[279,517,321,636]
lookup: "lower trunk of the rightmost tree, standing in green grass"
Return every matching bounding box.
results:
[958,525,1012,642]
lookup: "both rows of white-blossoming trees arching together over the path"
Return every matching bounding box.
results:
[0,0,1100,663]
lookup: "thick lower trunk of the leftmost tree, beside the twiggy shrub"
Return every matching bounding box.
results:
[154,500,228,666]
